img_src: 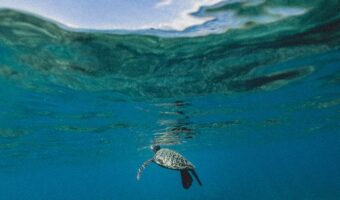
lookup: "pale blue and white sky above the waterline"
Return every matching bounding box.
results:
[0,0,221,31]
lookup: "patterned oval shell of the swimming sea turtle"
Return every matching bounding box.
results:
[153,149,194,170]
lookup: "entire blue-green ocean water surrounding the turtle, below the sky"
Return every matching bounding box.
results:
[0,0,340,200]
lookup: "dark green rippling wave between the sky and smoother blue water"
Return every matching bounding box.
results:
[0,1,340,98]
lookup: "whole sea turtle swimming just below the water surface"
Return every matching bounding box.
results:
[137,145,202,189]
